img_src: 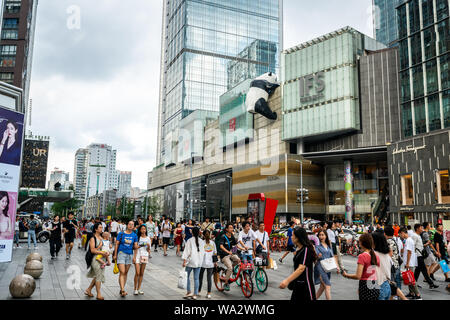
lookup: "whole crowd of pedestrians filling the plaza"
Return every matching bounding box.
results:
[20,212,450,301]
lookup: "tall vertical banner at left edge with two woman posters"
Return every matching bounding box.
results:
[0,107,24,262]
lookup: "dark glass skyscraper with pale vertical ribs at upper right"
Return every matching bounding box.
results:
[397,0,450,138]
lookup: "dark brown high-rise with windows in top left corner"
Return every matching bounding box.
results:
[0,0,38,111]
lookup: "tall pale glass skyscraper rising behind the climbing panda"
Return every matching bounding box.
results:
[157,0,282,166]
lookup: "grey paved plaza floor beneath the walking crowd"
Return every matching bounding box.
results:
[0,243,450,300]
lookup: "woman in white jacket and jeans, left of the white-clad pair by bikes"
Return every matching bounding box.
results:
[183,227,205,300]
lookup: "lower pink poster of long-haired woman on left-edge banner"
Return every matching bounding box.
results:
[0,191,17,240]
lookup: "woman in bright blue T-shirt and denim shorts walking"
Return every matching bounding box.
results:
[113,220,138,297]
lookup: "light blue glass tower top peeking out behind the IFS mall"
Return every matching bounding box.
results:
[372,0,405,46]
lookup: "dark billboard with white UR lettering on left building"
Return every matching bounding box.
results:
[20,139,49,189]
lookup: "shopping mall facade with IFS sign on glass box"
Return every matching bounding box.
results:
[149,27,401,222]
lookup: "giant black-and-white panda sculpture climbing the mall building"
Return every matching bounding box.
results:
[245,72,280,120]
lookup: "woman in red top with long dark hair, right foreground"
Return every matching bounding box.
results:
[342,233,380,301]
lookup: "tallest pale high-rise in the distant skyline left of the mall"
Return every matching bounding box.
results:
[86,143,117,198]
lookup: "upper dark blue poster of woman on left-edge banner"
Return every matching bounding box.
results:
[0,108,24,166]
